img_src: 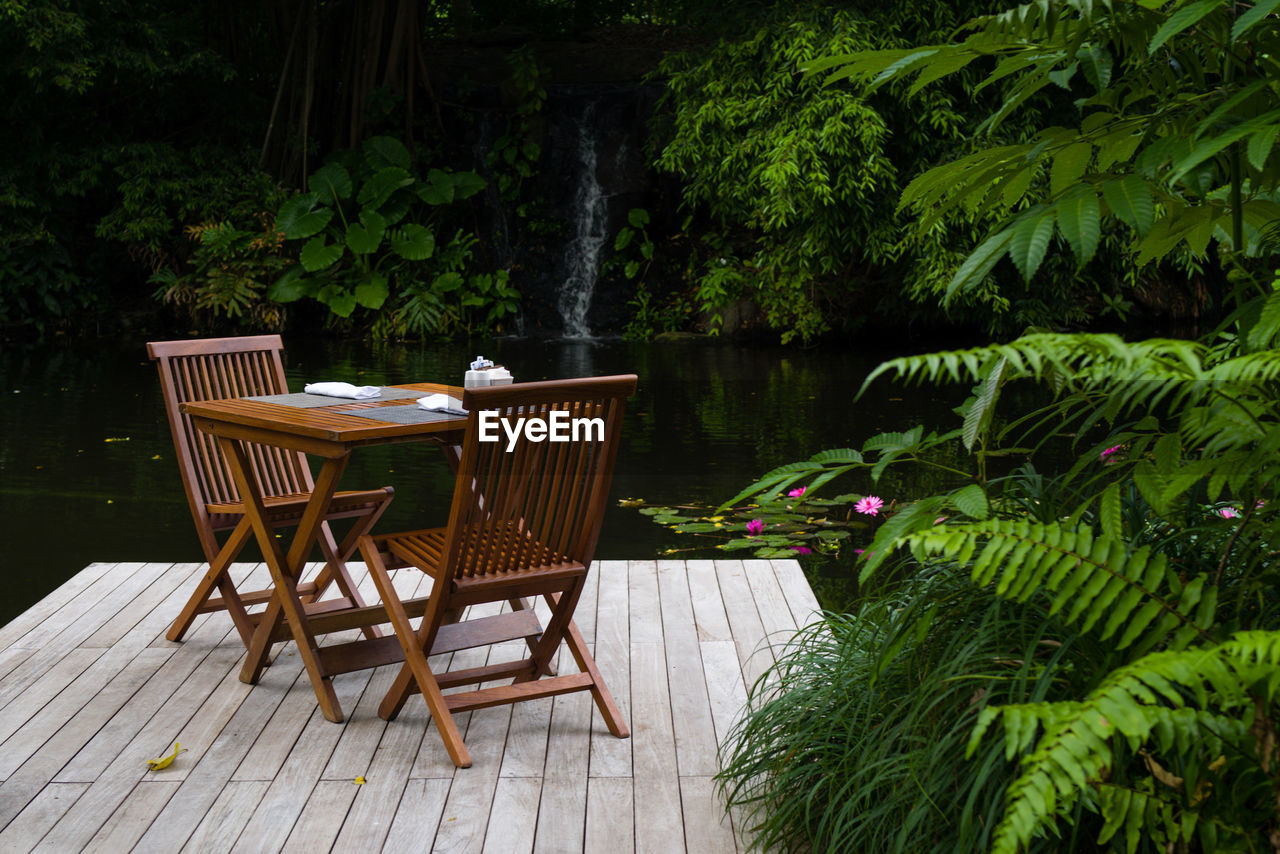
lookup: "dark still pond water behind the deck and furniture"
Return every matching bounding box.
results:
[0,335,964,625]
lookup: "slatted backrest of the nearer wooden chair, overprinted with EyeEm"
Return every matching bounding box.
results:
[442,374,636,580]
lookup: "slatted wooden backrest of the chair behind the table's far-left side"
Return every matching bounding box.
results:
[147,335,314,560]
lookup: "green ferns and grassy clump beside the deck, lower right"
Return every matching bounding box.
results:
[723,318,1280,853]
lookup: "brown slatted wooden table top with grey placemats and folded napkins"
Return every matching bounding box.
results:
[182,383,467,447]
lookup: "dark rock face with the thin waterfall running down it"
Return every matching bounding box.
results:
[435,38,659,338]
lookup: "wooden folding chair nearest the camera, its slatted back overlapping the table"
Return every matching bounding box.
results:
[360,374,636,768]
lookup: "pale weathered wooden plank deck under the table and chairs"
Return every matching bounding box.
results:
[0,561,817,854]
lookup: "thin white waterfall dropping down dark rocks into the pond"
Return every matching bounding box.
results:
[558,101,609,338]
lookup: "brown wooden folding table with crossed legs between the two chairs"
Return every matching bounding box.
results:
[182,383,467,721]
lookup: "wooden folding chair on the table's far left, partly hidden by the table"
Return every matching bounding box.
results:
[147,335,394,647]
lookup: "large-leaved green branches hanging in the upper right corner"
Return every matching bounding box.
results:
[809,0,1280,308]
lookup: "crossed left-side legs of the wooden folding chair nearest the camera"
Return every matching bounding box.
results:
[360,538,471,768]
